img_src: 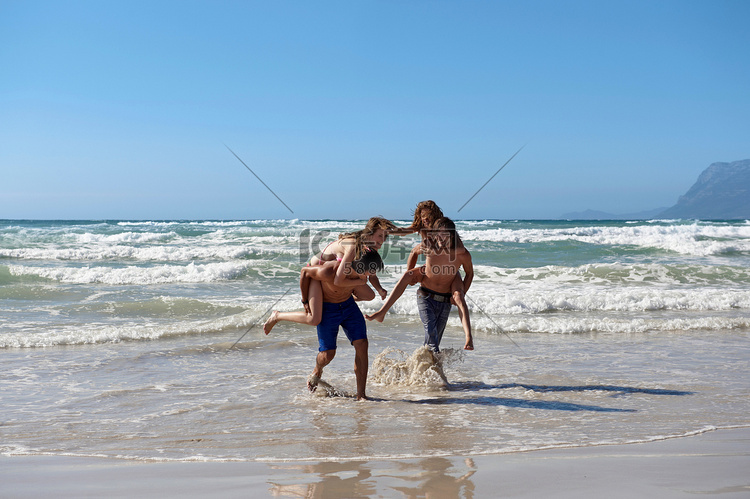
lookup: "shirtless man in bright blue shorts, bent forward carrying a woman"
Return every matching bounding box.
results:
[263,251,383,400]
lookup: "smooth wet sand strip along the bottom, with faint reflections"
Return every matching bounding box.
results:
[0,428,750,498]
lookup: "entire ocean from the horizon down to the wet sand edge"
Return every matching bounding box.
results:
[0,220,750,463]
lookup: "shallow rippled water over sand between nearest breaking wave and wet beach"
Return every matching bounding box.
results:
[0,326,750,460]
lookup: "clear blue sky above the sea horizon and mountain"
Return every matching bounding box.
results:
[0,0,750,219]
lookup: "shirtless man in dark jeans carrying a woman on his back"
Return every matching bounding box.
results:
[367,217,474,352]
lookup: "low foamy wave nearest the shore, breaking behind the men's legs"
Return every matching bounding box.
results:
[0,293,750,348]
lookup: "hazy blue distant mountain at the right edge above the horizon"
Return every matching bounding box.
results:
[658,159,750,220]
